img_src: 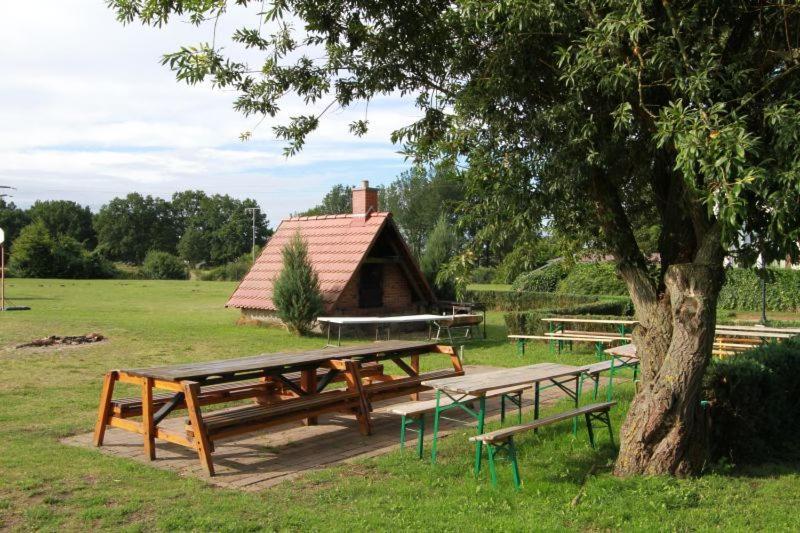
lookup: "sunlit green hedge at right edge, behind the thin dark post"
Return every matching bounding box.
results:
[719,268,800,311]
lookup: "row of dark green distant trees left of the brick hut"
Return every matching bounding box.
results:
[0,191,271,278]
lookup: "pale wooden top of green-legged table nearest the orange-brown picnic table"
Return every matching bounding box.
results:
[422,363,581,396]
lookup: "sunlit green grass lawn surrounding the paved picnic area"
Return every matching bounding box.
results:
[0,280,800,531]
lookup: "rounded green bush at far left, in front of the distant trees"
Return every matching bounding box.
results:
[9,220,116,279]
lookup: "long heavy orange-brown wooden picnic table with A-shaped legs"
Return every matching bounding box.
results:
[94,341,463,475]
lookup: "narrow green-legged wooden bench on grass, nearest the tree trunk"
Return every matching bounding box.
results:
[469,402,617,489]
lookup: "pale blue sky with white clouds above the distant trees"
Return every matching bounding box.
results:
[0,0,418,222]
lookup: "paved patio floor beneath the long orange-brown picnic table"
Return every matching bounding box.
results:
[62,366,624,491]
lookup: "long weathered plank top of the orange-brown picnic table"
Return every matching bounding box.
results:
[121,341,437,381]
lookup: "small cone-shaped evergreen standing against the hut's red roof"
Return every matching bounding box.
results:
[272,232,324,335]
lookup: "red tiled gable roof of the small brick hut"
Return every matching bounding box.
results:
[225,213,436,311]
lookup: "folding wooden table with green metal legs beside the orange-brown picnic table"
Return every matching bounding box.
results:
[423,363,583,468]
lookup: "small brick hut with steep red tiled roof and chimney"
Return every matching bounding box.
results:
[226,181,436,321]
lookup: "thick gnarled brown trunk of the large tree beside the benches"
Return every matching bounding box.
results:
[615,264,724,476]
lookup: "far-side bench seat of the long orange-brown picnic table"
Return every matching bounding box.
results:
[111,363,383,418]
